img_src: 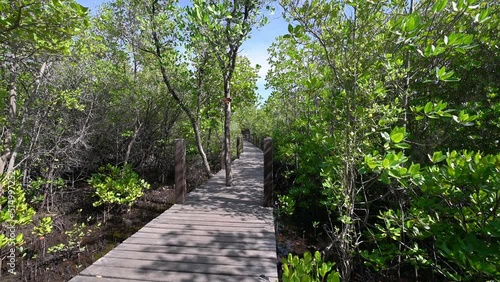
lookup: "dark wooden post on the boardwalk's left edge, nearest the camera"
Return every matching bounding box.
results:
[175,139,187,204]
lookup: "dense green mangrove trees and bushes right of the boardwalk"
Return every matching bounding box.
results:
[259,0,500,281]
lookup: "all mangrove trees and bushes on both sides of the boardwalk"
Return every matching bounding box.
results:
[0,0,500,281]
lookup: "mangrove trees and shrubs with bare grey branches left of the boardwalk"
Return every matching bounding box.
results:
[0,0,264,281]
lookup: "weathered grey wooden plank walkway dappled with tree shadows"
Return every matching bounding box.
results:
[70,142,278,282]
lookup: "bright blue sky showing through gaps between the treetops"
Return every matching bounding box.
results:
[73,0,288,101]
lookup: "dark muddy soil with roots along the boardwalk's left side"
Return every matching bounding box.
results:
[0,161,211,282]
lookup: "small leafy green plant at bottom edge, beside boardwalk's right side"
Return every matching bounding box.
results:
[283,251,340,282]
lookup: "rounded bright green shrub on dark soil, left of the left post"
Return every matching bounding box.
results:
[88,164,150,221]
